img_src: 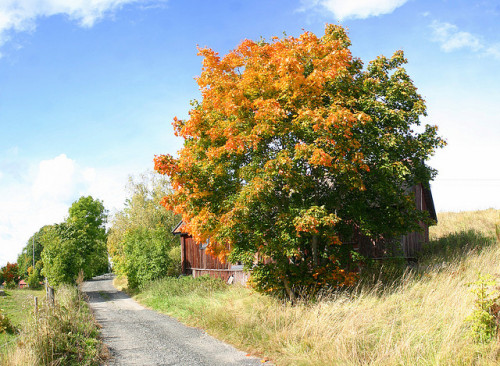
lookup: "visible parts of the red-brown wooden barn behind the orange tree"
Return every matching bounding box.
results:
[172,184,437,284]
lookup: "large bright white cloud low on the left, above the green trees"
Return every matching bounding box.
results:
[0,154,130,266]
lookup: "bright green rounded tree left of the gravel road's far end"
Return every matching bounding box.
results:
[41,196,108,285]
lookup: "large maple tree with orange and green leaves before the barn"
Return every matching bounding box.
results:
[155,25,444,298]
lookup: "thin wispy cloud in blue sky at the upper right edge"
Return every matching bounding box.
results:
[430,20,500,60]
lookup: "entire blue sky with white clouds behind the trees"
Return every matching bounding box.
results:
[0,0,500,265]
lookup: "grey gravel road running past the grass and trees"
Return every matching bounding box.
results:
[82,275,262,366]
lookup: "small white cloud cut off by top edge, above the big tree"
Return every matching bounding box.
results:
[303,0,408,20]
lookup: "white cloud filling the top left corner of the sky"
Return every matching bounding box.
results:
[0,0,164,45]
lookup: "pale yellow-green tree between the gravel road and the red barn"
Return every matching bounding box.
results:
[108,173,180,287]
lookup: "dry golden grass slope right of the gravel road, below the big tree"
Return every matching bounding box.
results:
[136,210,500,365]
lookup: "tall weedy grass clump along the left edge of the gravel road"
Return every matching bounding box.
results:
[1,286,107,366]
